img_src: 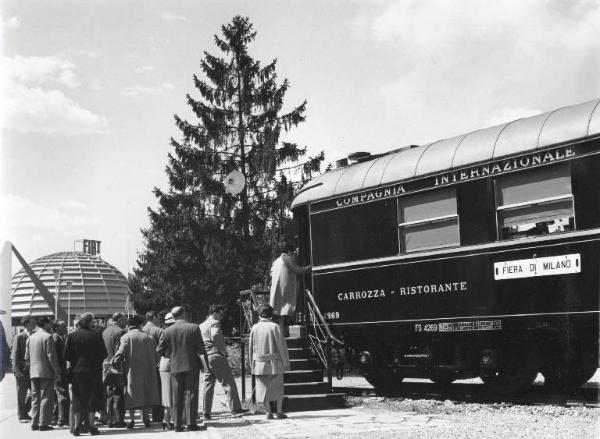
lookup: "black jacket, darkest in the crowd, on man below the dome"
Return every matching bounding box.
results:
[65,328,107,376]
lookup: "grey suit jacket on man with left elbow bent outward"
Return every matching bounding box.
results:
[156,321,206,373]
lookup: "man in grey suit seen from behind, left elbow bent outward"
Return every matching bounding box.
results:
[156,306,208,432]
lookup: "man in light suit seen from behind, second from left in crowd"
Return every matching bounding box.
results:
[25,316,60,431]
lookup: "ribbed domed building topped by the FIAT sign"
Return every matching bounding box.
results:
[11,251,129,324]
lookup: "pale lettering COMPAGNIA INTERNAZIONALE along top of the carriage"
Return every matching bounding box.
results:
[322,146,577,212]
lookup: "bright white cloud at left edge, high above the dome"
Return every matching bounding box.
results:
[0,56,108,135]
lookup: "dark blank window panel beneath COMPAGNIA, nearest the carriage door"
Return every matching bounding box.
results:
[310,199,398,265]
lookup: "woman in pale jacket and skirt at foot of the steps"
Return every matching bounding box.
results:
[248,305,290,419]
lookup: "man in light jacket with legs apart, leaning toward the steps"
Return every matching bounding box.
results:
[200,305,244,419]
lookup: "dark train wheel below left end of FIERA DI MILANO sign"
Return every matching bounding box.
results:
[481,343,537,395]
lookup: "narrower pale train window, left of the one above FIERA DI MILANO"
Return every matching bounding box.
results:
[398,188,460,252]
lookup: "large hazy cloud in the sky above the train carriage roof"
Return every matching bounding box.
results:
[354,0,600,143]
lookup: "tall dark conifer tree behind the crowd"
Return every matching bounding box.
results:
[132,16,324,324]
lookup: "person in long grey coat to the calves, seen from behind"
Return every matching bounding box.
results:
[113,315,160,429]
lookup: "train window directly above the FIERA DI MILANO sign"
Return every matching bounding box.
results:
[496,164,575,239]
